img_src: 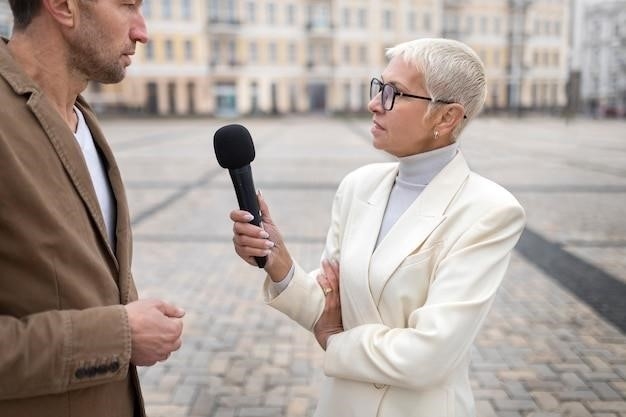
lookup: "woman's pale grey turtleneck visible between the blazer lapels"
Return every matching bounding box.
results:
[376,142,459,246]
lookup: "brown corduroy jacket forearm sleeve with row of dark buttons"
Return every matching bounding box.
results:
[0,305,131,400]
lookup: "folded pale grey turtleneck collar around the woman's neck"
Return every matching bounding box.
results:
[396,142,459,186]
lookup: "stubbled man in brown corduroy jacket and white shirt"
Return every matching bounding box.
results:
[0,0,184,417]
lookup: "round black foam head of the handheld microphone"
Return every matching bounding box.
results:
[213,124,254,169]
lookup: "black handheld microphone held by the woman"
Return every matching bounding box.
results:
[213,124,267,268]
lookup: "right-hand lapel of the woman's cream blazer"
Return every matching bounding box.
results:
[369,152,469,303]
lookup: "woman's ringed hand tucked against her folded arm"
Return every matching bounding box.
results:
[313,260,343,350]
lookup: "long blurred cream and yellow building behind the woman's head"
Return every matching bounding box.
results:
[86,0,569,116]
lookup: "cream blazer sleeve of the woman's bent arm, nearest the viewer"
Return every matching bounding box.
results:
[324,204,524,389]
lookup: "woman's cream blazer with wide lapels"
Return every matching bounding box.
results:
[265,153,525,417]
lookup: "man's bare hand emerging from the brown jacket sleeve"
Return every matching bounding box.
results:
[125,300,185,366]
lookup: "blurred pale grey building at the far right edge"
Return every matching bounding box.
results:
[581,0,626,117]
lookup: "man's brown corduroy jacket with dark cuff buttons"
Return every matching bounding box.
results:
[0,40,145,417]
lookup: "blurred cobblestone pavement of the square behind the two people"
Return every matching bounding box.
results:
[104,116,626,417]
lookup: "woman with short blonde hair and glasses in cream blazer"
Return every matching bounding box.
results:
[231,39,524,417]
